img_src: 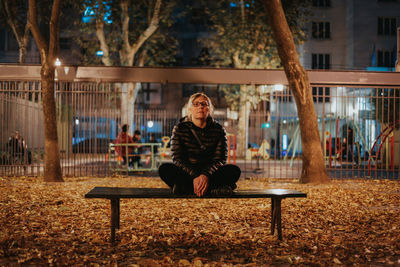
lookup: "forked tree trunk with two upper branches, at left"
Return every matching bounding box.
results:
[28,0,64,182]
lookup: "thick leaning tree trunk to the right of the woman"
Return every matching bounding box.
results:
[265,0,330,183]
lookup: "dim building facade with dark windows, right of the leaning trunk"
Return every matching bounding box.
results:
[299,0,400,71]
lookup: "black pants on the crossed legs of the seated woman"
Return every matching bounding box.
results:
[158,163,241,194]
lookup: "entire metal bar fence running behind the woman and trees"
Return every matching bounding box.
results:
[0,66,400,179]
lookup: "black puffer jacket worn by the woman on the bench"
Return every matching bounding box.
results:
[171,117,227,178]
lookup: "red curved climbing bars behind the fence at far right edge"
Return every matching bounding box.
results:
[368,120,400,175]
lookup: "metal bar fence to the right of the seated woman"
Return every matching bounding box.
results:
[247,86,400,179]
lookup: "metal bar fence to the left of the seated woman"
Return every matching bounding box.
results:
[0,81,181,176]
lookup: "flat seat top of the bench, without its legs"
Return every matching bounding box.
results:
[85,187,307,199]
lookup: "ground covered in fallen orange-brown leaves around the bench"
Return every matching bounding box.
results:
[0,177,400,266]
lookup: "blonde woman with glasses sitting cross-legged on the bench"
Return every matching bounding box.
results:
[158,93,241,197]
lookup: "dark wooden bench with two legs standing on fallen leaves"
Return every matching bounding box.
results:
[85,187,307,243]
